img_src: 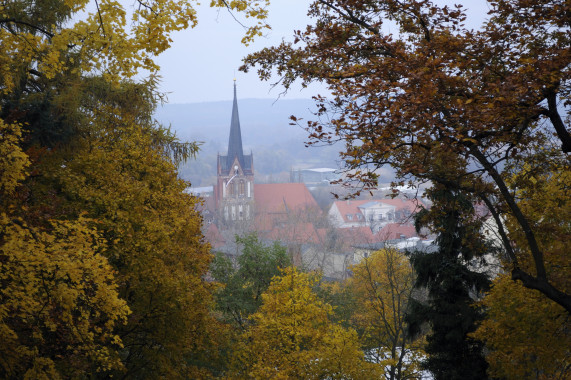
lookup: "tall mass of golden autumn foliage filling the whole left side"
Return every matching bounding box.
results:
[0,0,265,378]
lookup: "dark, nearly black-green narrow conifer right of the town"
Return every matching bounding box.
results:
[406,185,489,380]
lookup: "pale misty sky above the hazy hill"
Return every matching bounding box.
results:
[153,0,488,103]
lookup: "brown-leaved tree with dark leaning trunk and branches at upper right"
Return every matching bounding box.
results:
[243,0,571,312]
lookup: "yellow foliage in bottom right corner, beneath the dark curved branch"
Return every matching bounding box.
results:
[473,274,571,380]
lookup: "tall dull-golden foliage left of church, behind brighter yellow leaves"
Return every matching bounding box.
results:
[46,95,217,378]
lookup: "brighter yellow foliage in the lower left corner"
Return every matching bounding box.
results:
[0,213,129,379]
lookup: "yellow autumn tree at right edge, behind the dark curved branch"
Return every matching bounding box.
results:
[473,151,571,379]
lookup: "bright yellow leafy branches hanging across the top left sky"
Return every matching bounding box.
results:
[0,0,269,93]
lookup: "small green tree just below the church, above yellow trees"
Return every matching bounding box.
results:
[211,233,291,329]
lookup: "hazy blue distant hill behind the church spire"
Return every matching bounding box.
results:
[155,99,346,186]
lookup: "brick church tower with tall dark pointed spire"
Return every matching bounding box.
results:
[215,80,254,224]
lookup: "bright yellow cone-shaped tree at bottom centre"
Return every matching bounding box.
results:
[231,267,376,379]
